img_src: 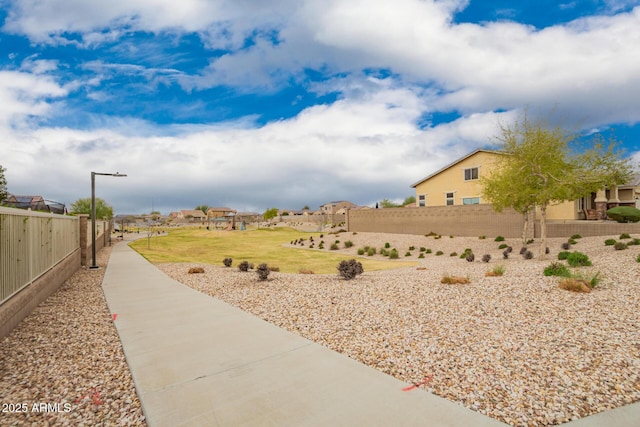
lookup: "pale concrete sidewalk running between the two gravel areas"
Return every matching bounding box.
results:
[102,243,637,427]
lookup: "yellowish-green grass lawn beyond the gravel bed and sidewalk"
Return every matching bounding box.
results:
[131,228,417,274]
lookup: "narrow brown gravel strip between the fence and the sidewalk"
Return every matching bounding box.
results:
[0,248,146,426]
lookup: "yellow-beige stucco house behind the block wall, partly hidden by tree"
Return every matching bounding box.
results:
[411,149,640,220]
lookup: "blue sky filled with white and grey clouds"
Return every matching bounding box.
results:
[0,0,640,213]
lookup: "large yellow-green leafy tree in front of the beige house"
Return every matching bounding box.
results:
[481,113,633,259]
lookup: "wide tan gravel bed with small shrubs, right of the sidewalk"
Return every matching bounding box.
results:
[159,233,640,426]
